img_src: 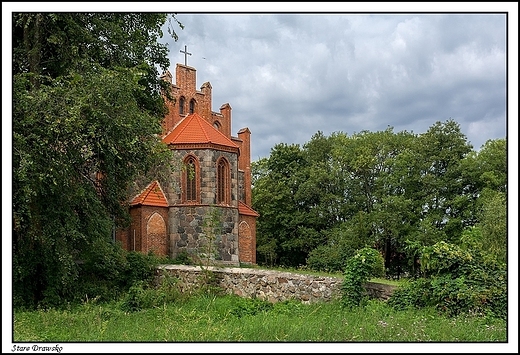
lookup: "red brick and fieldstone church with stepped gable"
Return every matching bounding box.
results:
[116,60,258,265]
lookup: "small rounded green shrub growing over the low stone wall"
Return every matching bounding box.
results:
[341,248,384,307]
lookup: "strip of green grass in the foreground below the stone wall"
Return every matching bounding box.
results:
[13,296,507,342]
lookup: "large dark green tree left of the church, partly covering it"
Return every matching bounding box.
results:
[13,13,183,306]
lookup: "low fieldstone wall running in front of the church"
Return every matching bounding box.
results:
[157,265,394,303]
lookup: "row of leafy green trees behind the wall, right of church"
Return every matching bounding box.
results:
[253,119,507,277]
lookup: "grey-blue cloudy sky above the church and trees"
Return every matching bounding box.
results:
[154,8,508,160]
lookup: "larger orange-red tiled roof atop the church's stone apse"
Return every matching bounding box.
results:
[163,113,239,149]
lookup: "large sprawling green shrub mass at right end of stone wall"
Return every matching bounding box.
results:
[388,242,507,318]
